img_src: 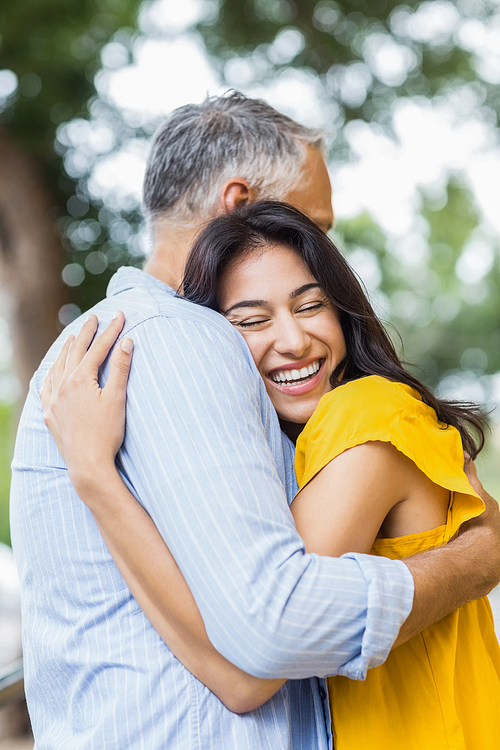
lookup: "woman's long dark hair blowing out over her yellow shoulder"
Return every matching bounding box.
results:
[182,201,485,458]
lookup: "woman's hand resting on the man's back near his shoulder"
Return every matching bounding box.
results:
[40,312,133,491]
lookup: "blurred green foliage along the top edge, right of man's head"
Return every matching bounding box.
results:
[198,0,500,142]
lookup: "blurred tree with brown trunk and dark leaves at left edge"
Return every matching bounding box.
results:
[0,0,139,396]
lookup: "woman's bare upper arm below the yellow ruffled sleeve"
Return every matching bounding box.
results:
[291,440,450,557]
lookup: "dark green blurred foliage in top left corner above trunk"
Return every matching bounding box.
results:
[0,0,137,146]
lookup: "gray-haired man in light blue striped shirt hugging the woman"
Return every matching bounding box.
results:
[8,94,500,750]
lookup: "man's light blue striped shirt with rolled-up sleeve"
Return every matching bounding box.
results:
[11,268,413,750]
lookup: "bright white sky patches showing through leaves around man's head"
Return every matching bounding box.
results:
[90,0,500,244]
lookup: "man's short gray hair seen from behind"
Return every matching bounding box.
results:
[143,91,324,224]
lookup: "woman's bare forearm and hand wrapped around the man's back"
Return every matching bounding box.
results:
[41,314,285,713]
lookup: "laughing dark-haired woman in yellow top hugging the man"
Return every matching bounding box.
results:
[42,202,500,750]
